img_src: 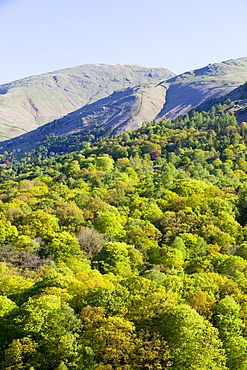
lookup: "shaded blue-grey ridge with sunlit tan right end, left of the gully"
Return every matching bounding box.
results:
[1,84,166,152]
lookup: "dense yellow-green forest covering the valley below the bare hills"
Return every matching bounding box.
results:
[0,104,247,370]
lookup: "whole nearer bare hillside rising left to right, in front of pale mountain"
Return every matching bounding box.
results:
[1,58,247,152]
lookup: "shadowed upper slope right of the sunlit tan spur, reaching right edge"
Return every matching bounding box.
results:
[157,58,247,119]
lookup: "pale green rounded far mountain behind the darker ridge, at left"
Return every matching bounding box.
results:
[0,64,175,140]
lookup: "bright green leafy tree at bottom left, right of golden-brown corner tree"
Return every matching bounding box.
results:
[13,295,81,370]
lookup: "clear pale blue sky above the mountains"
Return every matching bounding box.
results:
[0,0,247,84]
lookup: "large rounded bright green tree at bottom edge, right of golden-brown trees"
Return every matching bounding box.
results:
[160,304,226,370]
